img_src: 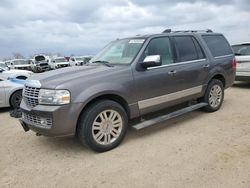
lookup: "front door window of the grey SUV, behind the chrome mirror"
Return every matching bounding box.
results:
[143,37,173,65]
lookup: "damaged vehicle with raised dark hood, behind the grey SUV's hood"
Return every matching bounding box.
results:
[31,54,50,73]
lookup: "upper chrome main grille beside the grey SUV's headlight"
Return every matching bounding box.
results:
[23,86,40,107]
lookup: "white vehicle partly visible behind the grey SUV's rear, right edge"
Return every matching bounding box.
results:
[232,43,250,81]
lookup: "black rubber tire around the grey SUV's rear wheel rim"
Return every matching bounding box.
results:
[202,79,224,112]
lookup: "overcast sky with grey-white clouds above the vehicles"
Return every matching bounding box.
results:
[0,0,250,59]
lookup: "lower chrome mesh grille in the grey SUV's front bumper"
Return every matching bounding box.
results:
[22,112,53,128]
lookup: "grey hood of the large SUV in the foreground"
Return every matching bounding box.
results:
[29,65,124,89]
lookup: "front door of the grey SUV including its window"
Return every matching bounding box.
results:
[134,37,185,115]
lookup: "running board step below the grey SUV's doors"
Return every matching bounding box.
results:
[132,103,208,130]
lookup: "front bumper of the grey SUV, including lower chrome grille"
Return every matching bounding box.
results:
[20,101,82,137]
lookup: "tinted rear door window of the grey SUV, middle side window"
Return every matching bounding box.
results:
[174,36,199,62]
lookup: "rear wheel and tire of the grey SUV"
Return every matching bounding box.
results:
[201,79,224,112]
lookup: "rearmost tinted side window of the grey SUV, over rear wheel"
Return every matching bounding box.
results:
[202,35,233,57]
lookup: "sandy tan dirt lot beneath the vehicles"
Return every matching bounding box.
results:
[0,83,250,188]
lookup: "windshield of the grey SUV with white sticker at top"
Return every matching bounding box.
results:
[90,39,145,64]
